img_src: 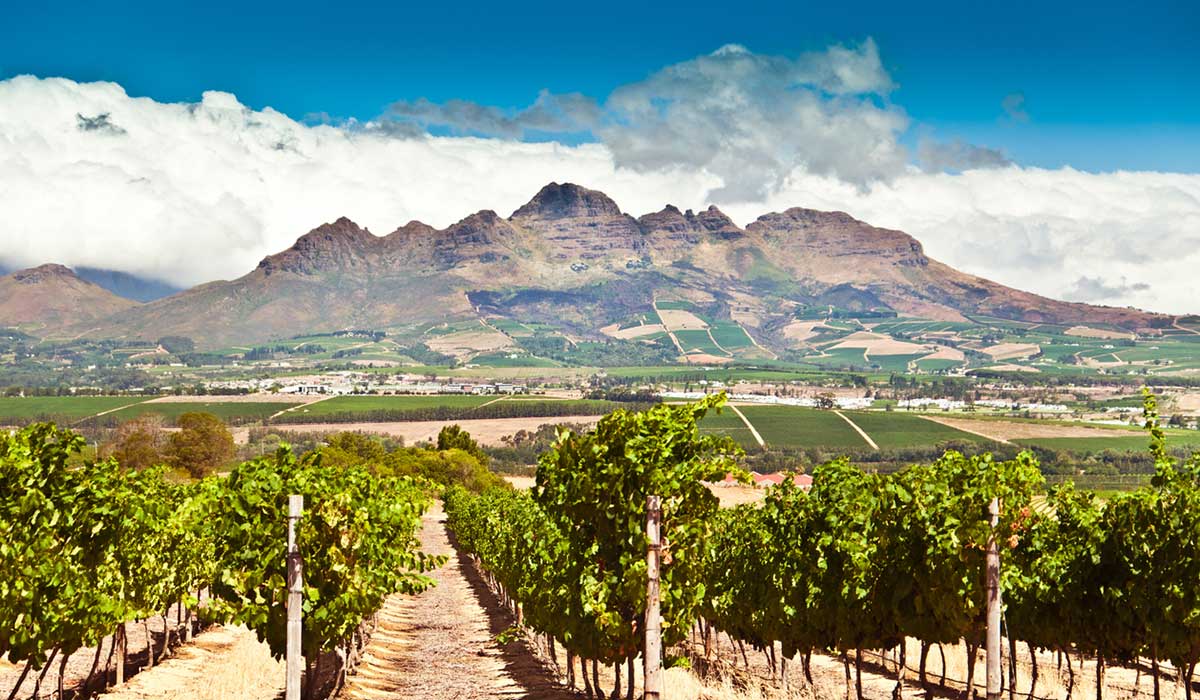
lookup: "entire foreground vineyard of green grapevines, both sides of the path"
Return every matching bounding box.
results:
[7,394,1200,700]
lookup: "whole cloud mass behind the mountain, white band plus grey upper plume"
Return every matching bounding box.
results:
[0,68,1200,312]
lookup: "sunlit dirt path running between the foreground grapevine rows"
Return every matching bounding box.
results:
[342,507,574,700]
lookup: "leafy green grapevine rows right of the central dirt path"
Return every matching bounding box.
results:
[446,396,1200,698]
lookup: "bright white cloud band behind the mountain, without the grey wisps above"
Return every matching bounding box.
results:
[0,75,1200,312]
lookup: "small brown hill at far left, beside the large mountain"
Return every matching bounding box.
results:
[0,264,138,336]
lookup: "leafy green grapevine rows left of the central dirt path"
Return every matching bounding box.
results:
[0,424,442,700]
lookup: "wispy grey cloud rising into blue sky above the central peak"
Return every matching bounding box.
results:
[389,40,908,203]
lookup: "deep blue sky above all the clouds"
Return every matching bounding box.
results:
[0,0,1200,172]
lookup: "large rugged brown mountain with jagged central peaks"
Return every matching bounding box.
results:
[23,183,1170,353]
